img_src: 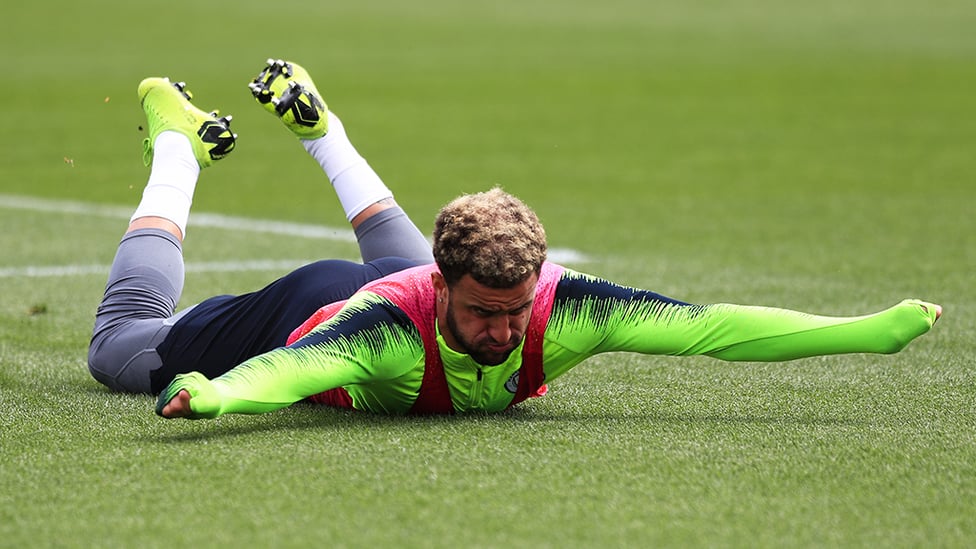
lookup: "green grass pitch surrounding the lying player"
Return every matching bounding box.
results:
[0,0,976,548]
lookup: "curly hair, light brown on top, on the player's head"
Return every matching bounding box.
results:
[434,187,546,288]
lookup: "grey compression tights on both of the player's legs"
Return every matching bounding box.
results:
[88,203,434,393]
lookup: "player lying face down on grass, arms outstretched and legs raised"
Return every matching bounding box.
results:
[90,58,942,419]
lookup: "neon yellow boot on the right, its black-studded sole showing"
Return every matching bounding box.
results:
[248,59,329,139]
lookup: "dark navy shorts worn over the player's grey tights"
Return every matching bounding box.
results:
[150,257,418,393]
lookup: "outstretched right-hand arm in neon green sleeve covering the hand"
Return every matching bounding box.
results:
[549,273,942,361]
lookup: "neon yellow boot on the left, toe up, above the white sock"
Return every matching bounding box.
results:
[139,77,237,168]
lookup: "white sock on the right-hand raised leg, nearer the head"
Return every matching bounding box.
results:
[302,111,393,221]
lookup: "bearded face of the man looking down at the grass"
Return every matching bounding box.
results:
[434,273,538,366]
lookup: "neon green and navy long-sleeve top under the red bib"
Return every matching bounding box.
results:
[157,269,938,418]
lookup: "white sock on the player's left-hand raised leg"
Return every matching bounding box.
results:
[132,131,200,237]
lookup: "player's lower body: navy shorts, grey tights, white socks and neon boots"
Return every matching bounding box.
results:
[88,60,433,393]
